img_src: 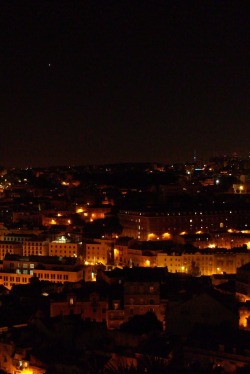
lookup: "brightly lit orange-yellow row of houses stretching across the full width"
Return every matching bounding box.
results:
[0,240,250,288]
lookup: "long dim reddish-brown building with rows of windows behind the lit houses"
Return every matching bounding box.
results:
[119,209,250,240]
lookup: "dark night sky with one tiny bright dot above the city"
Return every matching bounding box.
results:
[0,0,250,167]
